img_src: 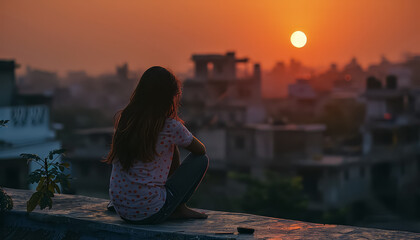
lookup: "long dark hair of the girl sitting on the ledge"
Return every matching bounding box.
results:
[104,66,183,171]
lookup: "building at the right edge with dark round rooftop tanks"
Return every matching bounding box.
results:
[362,75,420,203]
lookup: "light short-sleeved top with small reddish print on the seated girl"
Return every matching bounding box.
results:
[109,118,193,221]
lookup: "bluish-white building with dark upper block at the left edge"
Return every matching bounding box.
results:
[0,60,61,188]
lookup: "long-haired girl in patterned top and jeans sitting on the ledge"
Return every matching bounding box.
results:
[104,67,208,224]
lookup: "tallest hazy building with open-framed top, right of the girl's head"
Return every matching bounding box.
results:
[182,52,266,125]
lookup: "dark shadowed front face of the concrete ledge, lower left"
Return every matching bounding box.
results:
[0,210,236,240]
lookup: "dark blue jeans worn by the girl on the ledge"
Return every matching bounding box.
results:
[122,153,209,224]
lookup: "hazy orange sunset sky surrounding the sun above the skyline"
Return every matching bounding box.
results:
[0,0,420,74]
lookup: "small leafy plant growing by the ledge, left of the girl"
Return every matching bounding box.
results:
[20,149,70,212]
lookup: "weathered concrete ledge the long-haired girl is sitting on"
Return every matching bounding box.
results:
[0,189,420,239]
